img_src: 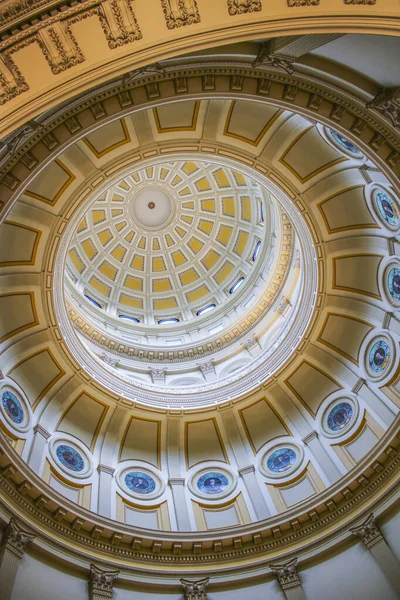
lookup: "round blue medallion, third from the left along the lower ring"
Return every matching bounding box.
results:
[116,465,165,500]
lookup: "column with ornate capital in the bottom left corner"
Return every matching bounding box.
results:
[0,519,35,600]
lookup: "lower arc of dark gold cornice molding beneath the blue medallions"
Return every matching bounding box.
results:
[0,416,400,574]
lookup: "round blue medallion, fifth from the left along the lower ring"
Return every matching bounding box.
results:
[260,438,304,479]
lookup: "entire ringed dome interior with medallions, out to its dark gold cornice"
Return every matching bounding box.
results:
[0,43,400,584]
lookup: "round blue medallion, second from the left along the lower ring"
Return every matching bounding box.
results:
[49,434,93,480]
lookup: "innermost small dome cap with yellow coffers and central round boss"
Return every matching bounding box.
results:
[67,161,272,325]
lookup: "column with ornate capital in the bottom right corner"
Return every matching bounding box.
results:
[350,514,400,593]
